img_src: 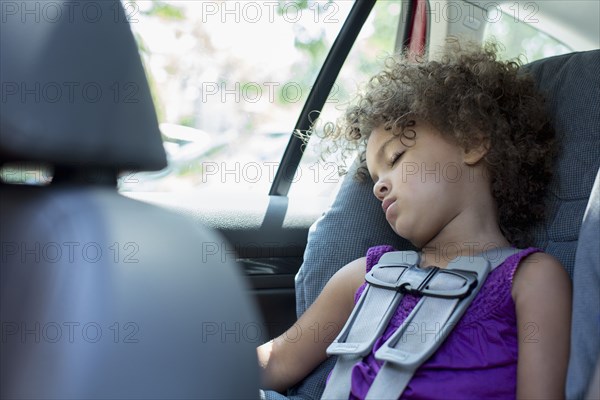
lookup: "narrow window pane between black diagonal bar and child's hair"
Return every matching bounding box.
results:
[289,1,403,196]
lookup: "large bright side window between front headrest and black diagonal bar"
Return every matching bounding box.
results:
[119,0,353,193]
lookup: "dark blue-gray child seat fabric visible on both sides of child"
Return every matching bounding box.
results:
[265,50,600,399]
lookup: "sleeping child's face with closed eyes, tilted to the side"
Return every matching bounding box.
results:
[366,120,477,247]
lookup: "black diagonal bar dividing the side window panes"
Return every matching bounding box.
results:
[269,0,376,196]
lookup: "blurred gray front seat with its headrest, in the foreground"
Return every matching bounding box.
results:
[0,1,261,399]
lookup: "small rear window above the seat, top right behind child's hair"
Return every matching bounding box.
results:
[484,3,573,63]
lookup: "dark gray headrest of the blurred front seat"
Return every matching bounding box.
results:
[0,0,166,170]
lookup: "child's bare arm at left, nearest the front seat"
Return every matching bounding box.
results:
[257,258,366,392]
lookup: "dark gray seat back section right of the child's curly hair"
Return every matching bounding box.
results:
[529,50,600,277]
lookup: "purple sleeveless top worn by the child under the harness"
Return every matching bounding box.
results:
[350,246,540,400]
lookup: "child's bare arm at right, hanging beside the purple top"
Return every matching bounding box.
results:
[512,253,571,399]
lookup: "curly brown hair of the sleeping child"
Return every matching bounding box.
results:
[326,40,555,247]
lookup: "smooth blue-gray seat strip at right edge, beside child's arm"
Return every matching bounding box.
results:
[567,170,600,399]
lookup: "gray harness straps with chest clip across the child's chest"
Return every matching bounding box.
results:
[322,248,519,399]
